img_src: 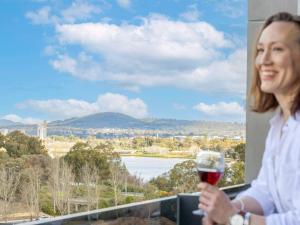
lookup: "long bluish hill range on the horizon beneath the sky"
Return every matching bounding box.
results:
[0,112,245,135]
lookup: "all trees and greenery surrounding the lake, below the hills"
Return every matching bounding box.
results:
[0,131,245,220]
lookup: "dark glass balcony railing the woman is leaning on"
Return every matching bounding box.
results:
[10,184,248,225]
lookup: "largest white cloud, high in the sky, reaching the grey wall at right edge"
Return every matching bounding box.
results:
[50,15,246,96]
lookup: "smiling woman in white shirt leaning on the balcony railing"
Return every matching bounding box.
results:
[199,13,300,225]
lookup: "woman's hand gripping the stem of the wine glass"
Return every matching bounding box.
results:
[198,182,236,224]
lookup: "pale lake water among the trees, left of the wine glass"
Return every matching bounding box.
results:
[121,156,188,181]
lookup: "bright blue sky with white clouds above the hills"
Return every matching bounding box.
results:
[0,0,247,124]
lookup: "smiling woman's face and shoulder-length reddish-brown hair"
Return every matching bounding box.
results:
[252,15,300,116]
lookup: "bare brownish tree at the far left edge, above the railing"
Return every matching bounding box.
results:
[0,166,20,221]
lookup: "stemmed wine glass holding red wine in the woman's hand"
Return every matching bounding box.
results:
[193,150,225,216]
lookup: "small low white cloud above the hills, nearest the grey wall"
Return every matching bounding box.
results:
[194,102,245,121]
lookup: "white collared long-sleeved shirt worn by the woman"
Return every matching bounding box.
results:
[239,112,300,225]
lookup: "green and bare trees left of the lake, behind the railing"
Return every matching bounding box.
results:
[0,131,156,221]
